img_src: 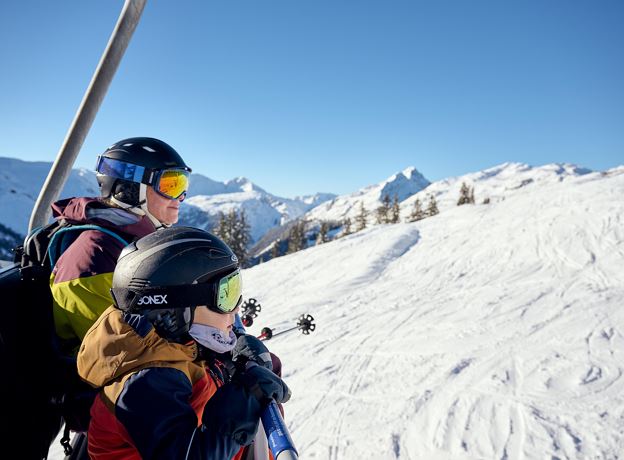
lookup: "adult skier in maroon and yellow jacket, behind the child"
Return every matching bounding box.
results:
[45,137,191,455]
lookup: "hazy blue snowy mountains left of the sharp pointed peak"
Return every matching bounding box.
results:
[0,157,336,259]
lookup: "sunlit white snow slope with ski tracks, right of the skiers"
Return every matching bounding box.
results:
[244,165,624,460]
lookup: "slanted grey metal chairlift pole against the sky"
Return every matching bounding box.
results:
[28,0,146,233]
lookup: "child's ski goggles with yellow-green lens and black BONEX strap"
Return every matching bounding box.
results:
[111,269,243,313]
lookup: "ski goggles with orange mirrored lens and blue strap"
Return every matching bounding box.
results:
[95,155,191,200]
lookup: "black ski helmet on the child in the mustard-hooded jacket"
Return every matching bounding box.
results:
[111,227,242,343]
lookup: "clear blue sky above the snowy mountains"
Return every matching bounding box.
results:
[0,0,624,197]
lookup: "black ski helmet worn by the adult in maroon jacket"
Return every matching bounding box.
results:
[96,137,191,207]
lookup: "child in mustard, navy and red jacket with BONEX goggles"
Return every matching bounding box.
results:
[78,227,290,460]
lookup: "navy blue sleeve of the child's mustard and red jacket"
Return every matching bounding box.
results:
[115,367,241,460]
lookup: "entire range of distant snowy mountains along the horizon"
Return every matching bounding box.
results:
[0,157,619,262]
